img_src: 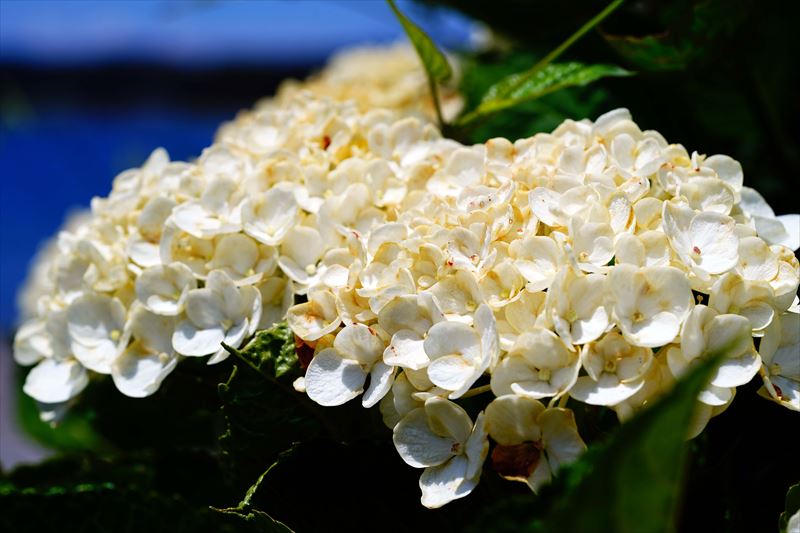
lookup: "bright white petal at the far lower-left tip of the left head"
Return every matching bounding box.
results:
[22,359,89,403]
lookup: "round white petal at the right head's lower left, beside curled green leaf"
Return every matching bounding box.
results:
[306,348,367,407]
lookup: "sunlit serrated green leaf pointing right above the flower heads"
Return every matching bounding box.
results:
[459,62,633,124]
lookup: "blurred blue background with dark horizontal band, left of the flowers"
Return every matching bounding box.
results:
[0,0,472,335]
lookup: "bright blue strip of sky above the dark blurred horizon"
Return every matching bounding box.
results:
[0,0,470,66]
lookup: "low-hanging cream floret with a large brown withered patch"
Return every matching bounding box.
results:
[486,394,586,492]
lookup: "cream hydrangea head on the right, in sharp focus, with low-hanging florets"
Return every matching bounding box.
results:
[288,110,800,507]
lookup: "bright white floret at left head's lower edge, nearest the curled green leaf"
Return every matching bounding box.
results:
[172,270,261,364]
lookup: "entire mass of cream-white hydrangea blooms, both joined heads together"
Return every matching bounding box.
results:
[15,43,800,508]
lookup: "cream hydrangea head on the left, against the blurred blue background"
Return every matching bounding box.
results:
[15,89,444,404]
